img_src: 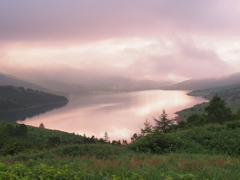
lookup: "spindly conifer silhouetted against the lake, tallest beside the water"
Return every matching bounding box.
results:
[153,109,173,133]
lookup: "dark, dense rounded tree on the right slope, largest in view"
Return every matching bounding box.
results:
[205,95,233,124]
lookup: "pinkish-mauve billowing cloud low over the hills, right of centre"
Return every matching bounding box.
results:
[132,39,232,78]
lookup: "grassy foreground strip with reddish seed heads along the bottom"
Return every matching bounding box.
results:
[0,144,240,180]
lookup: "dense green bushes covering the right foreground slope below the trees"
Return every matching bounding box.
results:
[128,118,240,156]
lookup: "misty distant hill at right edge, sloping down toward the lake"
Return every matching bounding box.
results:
[164,73,240,90]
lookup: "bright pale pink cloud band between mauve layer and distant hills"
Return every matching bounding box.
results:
[0,37,236,84]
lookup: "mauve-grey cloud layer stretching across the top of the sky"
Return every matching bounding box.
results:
[0,0,240,43]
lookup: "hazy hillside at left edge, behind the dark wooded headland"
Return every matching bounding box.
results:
[0,73,48,91]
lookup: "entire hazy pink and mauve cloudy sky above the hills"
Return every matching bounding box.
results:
[0,0,240,80]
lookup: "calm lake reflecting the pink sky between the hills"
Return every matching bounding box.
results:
[18,90,206,140]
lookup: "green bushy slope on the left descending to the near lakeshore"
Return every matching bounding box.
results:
[0,121,124,155]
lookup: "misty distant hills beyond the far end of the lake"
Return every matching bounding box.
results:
[34,77,173,94]
